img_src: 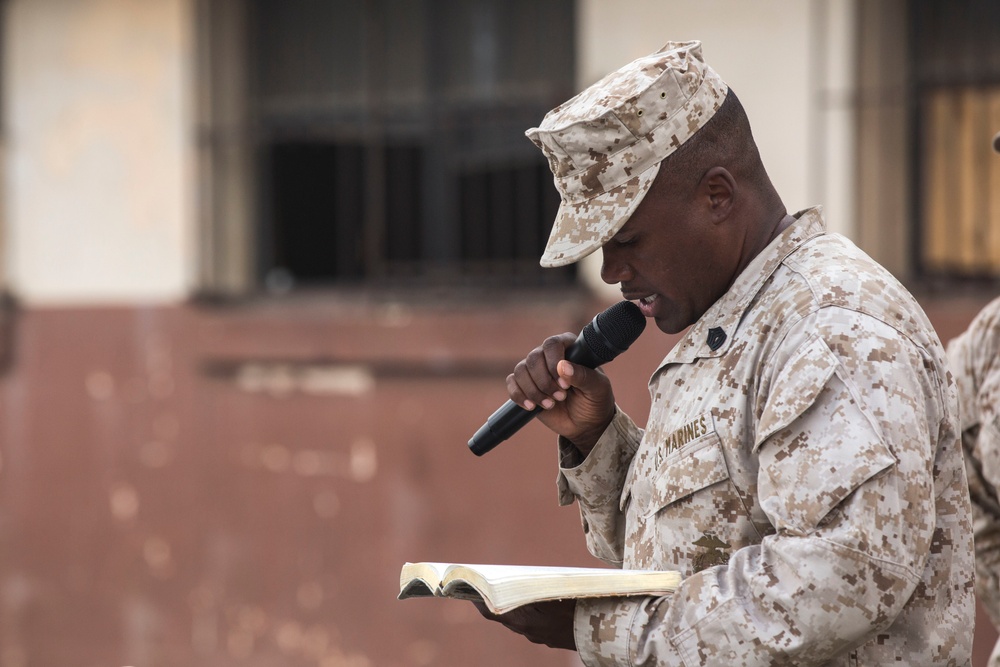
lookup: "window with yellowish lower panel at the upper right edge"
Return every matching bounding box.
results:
[910,0,1000,278]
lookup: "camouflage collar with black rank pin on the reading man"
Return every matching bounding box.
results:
[660,206,826,368]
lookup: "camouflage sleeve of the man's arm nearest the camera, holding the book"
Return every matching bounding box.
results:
[575,318,967,666]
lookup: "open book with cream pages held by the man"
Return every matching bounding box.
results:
[399,563,681,614]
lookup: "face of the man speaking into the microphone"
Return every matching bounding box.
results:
[601,167,738,333]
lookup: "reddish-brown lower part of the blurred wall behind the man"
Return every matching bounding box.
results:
[0,296,989,667]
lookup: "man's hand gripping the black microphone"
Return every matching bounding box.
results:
[507,333,615,455]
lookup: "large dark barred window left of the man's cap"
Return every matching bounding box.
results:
[248,0,575,287]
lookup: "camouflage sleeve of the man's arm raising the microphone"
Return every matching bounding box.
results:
[558,410,642,567]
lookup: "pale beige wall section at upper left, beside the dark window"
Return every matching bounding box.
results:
[3,0,194,304]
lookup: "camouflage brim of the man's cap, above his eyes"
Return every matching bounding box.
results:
[539,162,660,268]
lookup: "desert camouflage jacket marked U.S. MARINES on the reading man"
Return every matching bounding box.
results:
[559,209,974,666]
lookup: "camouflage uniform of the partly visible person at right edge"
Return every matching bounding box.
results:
[948,298,1000,667]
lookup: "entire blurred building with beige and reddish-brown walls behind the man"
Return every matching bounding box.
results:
[0,0,1000,667]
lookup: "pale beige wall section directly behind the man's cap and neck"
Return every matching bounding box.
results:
[577,0,855,292]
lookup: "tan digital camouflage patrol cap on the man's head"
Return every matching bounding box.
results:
[525,41,728,267]
